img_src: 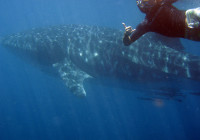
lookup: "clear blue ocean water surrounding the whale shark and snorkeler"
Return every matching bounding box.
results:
[0,0,200,140]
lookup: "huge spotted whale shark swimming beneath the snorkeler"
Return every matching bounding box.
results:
[0,24,200,96]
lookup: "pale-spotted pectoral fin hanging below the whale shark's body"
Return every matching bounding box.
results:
[53,60,92,97]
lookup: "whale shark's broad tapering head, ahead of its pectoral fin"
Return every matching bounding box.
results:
[0,29,66,65]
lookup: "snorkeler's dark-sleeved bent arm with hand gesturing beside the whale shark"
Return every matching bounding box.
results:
[123,21,147,46]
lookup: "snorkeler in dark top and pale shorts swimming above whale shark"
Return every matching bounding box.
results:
[122,0,200,46]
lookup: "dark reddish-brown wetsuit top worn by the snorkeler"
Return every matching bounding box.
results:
[123,0,186,46]
